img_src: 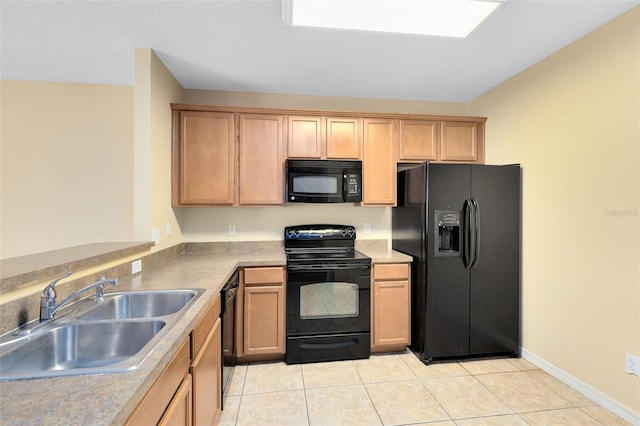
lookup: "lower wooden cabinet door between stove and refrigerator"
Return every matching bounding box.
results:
[372,280,410,347]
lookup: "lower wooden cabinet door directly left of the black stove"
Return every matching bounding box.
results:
[243,283,285,355]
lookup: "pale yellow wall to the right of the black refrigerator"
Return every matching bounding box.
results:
[470,7,640,415]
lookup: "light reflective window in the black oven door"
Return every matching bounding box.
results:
[300,282,359,320]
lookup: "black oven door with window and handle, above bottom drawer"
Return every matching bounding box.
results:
[287,263,371,337]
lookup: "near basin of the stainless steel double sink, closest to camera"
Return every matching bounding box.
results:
[0,320,166,380]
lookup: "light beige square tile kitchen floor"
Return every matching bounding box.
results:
[220,351,628,426]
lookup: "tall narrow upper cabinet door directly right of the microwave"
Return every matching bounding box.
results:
[362,119,396,205]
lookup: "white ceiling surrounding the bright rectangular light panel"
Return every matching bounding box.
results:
[0,0,640,102]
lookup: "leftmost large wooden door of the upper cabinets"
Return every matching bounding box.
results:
[174,111,235,205]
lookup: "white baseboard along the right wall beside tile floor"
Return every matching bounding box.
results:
[522,348,640,425]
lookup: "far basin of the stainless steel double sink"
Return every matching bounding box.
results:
[77,290,198,320]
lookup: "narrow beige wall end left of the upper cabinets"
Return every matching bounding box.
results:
[133,48,183,250]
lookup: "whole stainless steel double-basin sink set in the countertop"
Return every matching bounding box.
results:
[0,289,204,380]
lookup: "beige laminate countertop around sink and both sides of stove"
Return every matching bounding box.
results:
[0,248,411,425]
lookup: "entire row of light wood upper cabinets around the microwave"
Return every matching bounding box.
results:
[171,104,486,207]
